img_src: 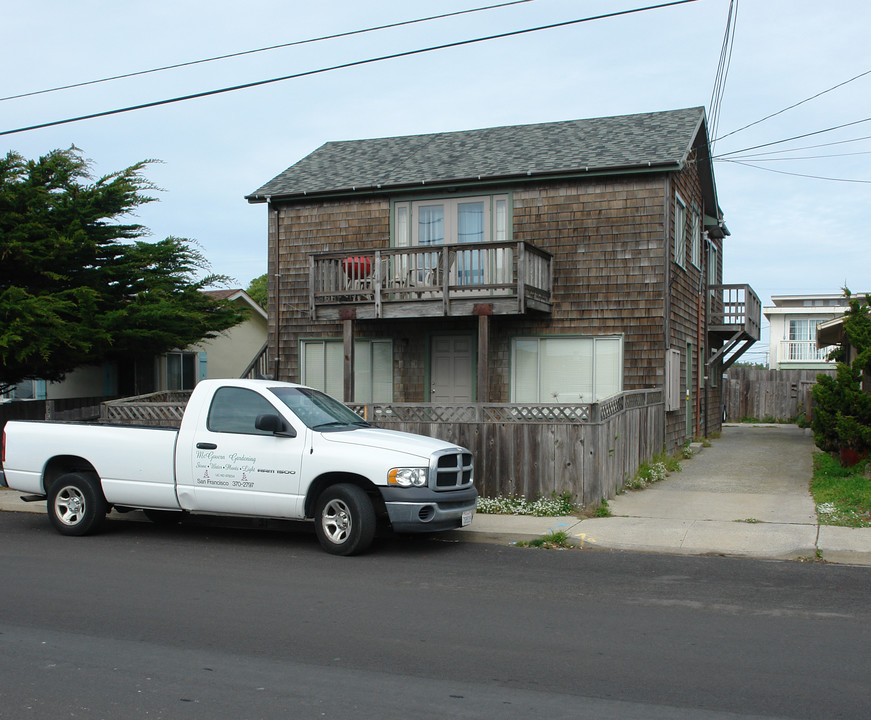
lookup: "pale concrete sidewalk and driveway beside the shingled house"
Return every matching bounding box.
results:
[0,425,871,566]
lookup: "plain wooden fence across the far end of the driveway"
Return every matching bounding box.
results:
[723,367,835,422]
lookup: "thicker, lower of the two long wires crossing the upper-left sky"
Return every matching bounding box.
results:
[0,0,696,137]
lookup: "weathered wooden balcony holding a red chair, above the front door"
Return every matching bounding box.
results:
[309,242,553,321]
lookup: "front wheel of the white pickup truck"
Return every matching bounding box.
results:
[315,484,376,555]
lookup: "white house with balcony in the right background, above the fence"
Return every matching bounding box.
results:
[762,292,848,370]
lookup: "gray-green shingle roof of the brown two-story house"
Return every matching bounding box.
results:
[247,107,707,202]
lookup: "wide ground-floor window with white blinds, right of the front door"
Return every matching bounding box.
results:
[511,336,623,403]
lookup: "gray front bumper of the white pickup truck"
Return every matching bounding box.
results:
[379,487,478,533]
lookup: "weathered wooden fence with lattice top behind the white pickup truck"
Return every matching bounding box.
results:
[103,389,665,506]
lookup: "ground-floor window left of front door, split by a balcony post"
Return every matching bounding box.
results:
[300,339,393,402]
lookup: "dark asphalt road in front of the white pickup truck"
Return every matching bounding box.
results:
[0,513,871,720]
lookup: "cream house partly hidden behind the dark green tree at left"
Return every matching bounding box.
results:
[1,289,266,400]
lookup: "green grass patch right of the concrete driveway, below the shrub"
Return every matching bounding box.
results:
[811,453,871,527]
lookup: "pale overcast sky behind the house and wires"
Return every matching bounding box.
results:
[0,0,871,359]
